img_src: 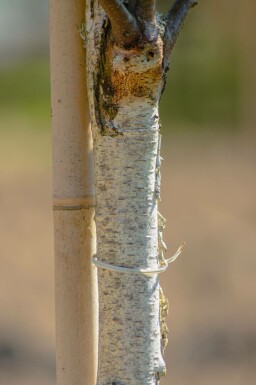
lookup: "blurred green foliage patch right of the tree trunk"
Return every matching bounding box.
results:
[160,9,243,130]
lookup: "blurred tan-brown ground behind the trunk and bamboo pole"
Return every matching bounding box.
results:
[0,127,256,385]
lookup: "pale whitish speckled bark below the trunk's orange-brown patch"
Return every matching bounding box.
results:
[95,106,165,385]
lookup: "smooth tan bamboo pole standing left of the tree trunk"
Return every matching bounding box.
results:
[50,0,98,385]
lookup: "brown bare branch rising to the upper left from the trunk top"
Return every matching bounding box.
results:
[100,0,140,45]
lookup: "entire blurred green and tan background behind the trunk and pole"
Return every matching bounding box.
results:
[0,0,256,385]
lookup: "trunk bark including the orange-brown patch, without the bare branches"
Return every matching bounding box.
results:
[87,4,165,385]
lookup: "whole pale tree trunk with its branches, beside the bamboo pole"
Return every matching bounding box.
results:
[83,0,196,385]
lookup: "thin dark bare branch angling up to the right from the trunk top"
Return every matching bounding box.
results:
[165,0,198,52]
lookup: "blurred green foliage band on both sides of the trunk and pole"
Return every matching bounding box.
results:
[0,2,243,131]
